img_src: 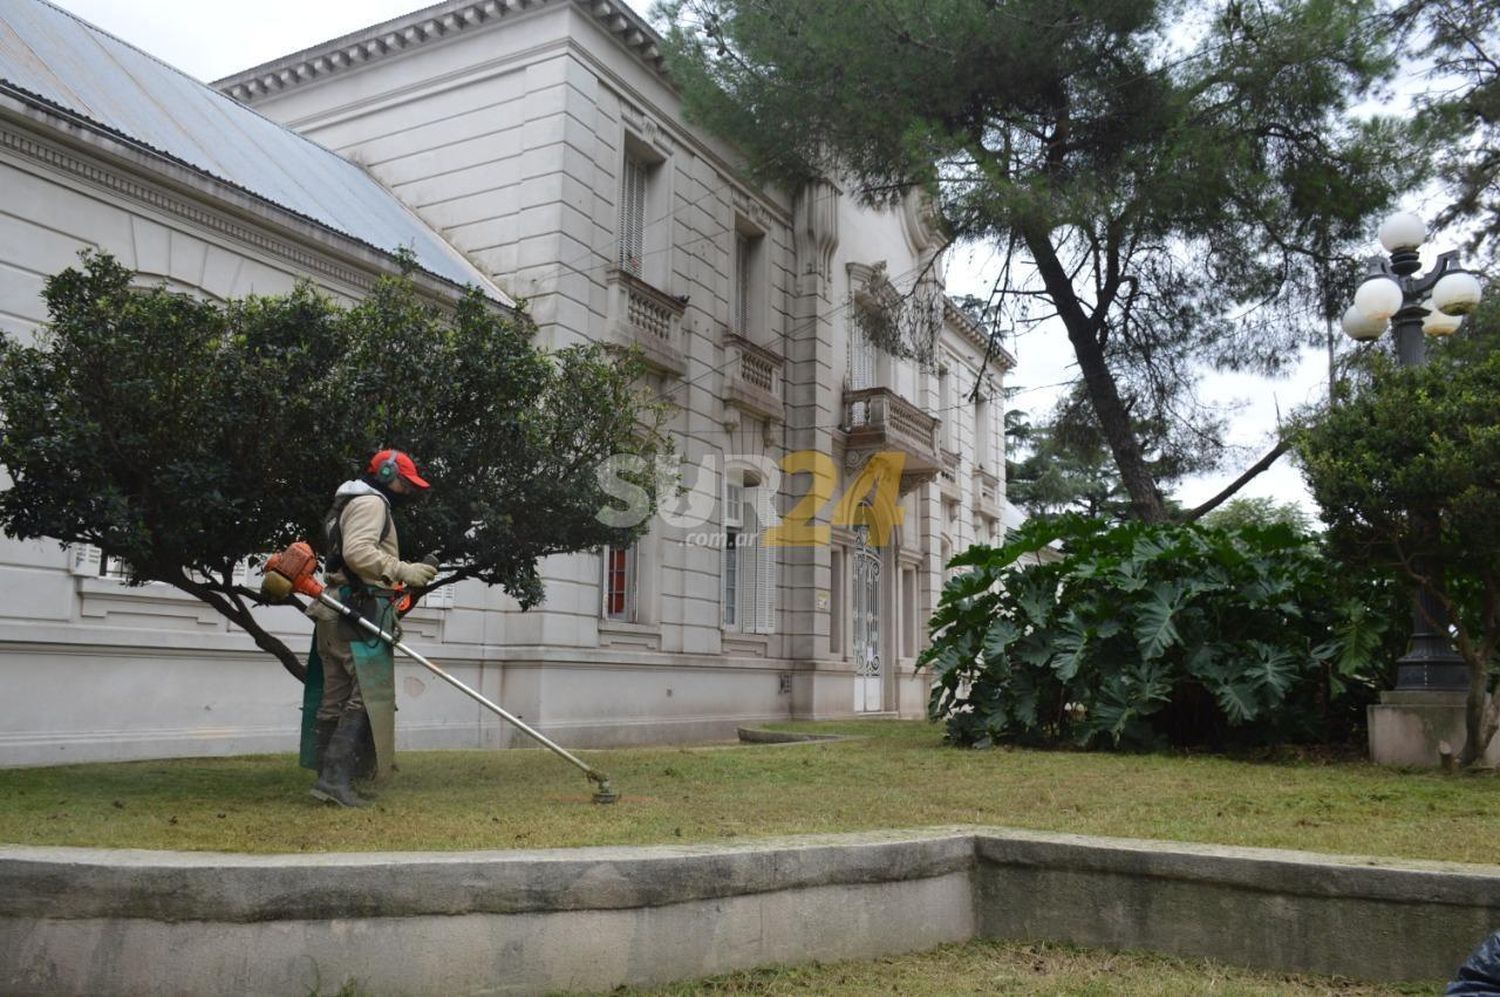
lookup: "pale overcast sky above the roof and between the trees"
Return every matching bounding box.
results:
[38,0,1436,511]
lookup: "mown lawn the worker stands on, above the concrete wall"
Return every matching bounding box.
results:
[0,721,1500,864]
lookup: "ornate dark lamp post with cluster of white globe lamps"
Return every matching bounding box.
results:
[1343,213,1481,691]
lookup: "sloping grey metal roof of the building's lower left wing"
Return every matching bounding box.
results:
[0,0,512,304]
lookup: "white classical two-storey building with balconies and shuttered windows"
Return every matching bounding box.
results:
[0,0,1011,763]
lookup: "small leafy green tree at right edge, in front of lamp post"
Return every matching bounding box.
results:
[1299,314,1500,766]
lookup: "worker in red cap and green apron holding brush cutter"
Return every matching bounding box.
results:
[302,450,438,807]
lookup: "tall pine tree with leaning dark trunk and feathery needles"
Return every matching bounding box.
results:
[662,0,1424,520]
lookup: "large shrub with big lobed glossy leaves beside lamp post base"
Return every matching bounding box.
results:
[918,516,1386,748]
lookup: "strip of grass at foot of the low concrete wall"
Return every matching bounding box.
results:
[588,942,1440,997]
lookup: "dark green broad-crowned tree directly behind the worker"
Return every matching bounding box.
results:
[0,253,660,679]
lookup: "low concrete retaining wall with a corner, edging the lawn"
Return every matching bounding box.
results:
[0,829,1500,997]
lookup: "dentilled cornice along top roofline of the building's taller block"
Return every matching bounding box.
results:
[210,0,668,105]
